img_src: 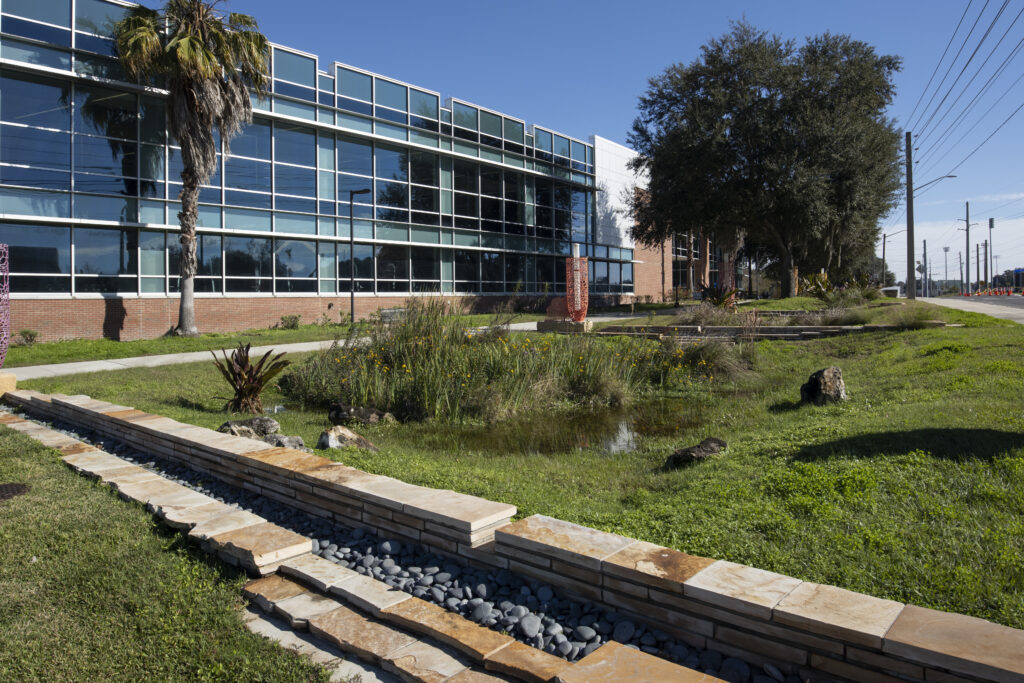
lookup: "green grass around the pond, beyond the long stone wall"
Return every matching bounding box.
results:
[25,303,1024,628]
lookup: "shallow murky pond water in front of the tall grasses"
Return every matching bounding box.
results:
[403,399,701,455]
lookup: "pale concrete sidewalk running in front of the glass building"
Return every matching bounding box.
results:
[12,309,672,382]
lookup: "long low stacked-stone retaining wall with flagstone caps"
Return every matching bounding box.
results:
[4,391,1024,683]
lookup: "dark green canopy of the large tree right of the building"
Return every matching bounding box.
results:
[629,23,901,296]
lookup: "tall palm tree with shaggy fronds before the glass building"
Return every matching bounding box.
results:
[115,0,269,337]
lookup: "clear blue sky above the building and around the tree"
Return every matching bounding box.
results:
[234,0,1024,280]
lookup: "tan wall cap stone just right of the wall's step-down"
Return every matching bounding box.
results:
[495,515,636,571]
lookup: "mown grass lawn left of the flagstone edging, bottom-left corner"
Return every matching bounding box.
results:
[0,427,328,681]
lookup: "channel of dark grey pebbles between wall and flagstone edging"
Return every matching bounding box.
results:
[12,415,782,683]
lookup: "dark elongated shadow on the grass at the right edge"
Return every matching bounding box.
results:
[797,428,1024,461]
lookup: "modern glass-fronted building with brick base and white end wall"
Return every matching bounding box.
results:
[0,0,673,339]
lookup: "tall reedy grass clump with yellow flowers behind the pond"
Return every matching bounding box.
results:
[281,299,692,420]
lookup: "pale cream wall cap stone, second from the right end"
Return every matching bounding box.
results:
[772,582,903,649]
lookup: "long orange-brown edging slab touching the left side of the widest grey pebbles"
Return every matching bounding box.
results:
[381,598,514,661]
